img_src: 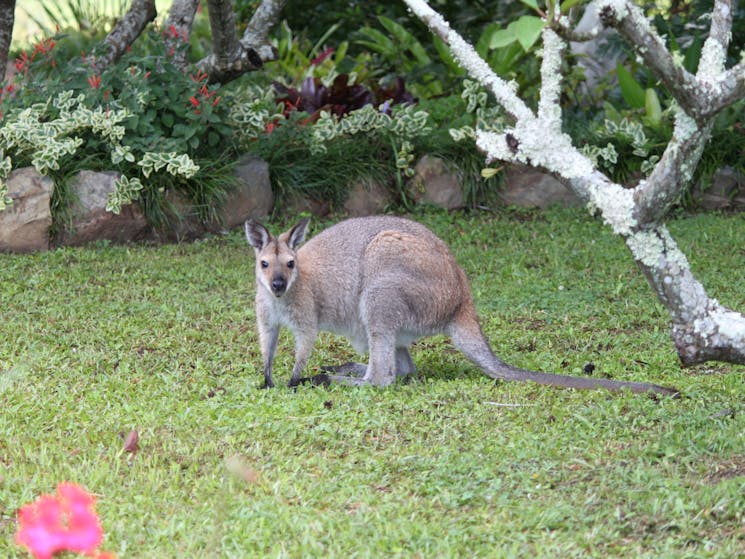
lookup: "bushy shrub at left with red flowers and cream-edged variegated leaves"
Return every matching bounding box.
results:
[0,27,241,230]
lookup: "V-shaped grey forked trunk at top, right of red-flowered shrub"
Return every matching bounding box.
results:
[197,0,285,82]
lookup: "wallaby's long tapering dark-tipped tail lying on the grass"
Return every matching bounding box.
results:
[449,313,680,398]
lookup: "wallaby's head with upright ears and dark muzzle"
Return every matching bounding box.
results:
[245,217,310,297]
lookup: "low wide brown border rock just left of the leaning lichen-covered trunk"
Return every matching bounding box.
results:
[497,166,581,209]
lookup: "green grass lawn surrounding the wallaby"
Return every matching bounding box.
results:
[0,210,745,558]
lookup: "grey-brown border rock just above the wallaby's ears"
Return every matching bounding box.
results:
[220,155,274,229]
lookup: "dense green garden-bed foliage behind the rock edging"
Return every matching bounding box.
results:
[0,0,745,226]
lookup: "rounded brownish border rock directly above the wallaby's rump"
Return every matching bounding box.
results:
[407,155,465,210]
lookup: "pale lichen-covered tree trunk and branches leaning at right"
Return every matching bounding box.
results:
[404,0,745,365]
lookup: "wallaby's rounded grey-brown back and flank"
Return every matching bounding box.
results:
[298,216,470,335]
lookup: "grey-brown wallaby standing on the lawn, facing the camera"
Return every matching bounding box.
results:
[245,216,678,396]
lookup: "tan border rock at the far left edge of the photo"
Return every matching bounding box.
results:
[0,167,54,252]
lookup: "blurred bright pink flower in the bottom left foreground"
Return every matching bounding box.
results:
[16,482,109,559]
